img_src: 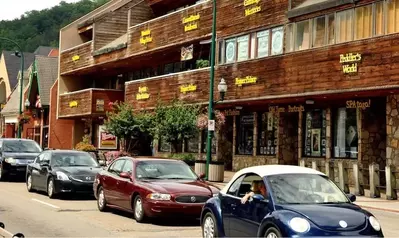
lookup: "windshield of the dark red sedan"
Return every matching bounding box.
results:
[136,161,198,180]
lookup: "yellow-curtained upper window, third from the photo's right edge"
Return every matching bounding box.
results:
[355,4,373,40]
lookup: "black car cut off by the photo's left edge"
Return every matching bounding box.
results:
[0,139,42,180]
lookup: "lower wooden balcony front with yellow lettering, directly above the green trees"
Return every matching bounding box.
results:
[125,68,210,109]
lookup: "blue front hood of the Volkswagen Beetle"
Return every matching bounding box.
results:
[276,203,367,231]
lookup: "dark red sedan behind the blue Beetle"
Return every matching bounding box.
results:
[93,157,219,222]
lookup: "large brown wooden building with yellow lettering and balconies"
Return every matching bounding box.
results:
[57,0,399,193]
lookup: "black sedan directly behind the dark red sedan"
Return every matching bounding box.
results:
[26,150,102,198]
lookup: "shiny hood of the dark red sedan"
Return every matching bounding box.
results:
[142,180,216,196]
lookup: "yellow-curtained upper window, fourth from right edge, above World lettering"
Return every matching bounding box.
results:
[337,9,353,43]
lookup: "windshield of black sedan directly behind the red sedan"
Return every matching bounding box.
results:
[51,153,99,167]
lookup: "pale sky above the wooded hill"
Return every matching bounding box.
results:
[0,0,79,20]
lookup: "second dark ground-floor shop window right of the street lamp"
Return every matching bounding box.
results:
[257,112,278,155]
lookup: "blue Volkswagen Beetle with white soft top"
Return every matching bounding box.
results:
[201,165,384,238]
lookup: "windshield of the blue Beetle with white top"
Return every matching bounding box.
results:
[267,174,349,204]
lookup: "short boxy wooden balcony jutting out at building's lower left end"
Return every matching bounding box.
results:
[58,88,124,118]
